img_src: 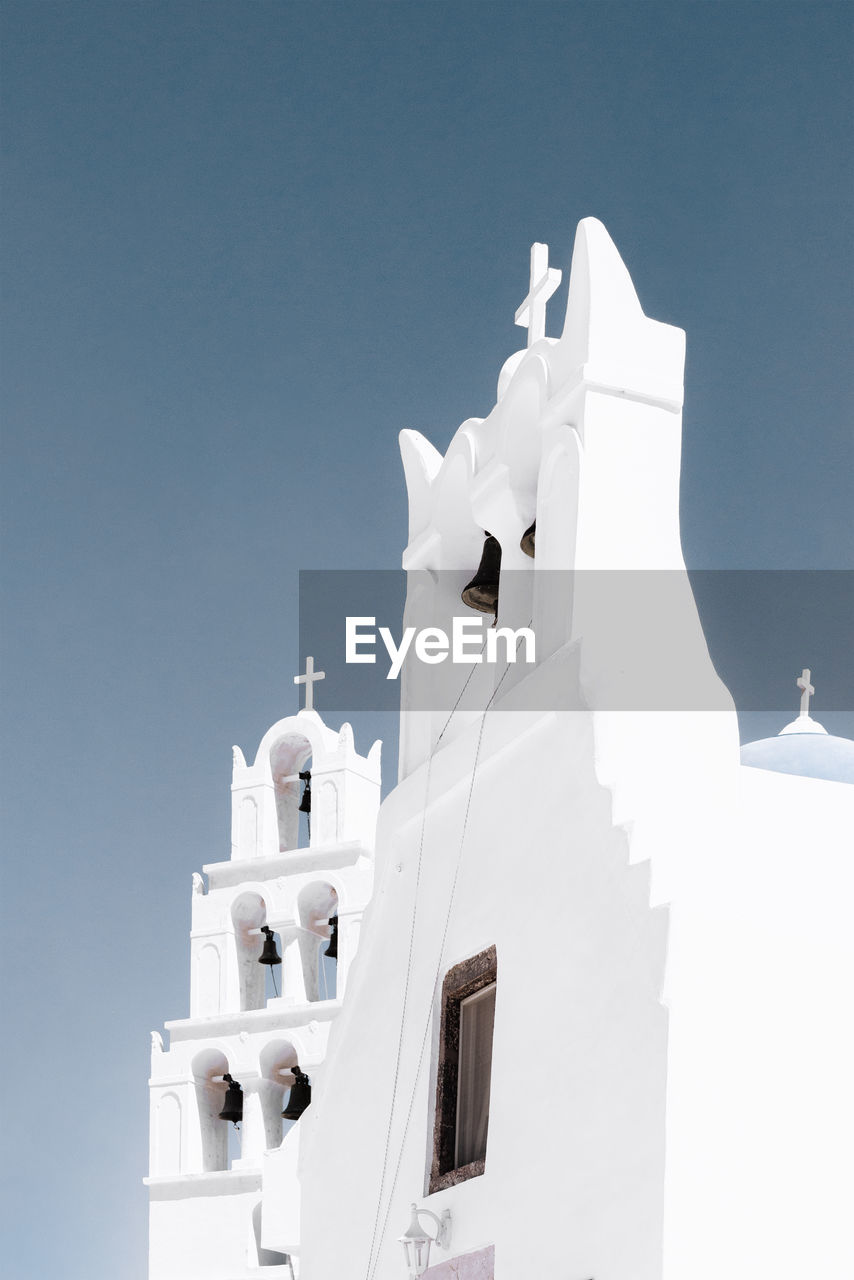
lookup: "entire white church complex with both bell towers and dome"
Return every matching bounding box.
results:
[146,219,854,1280]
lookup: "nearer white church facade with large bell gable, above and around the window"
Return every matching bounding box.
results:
[297,219,717,1280]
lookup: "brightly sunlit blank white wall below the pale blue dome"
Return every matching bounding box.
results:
[665,768,854,1280]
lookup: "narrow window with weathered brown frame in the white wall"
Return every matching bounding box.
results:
[430,947,498,1193]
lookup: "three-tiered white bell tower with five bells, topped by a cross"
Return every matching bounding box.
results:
[146,658,380,1280]
